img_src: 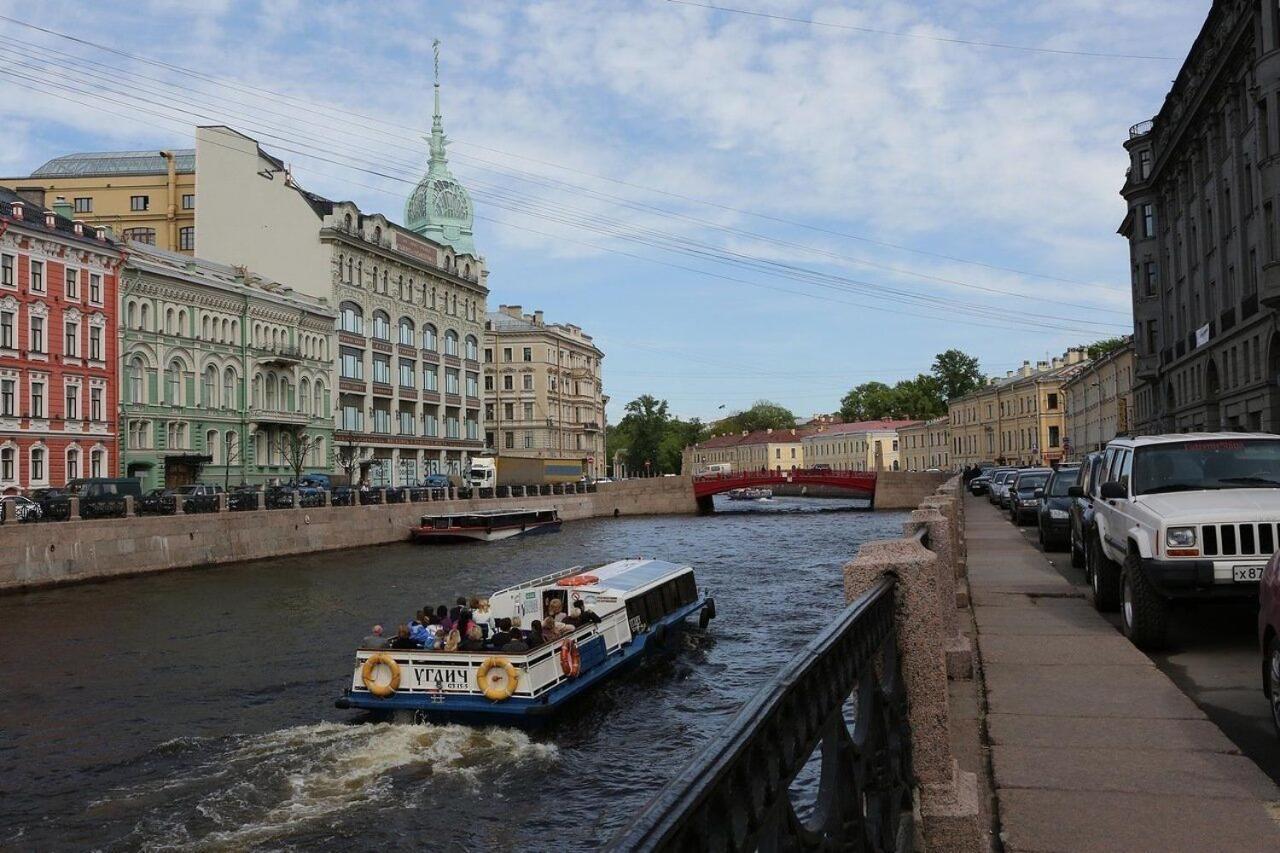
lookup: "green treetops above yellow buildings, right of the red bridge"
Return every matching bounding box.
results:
[840,350,983,421]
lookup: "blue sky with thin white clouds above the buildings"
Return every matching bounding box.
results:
[0,0,1210,423]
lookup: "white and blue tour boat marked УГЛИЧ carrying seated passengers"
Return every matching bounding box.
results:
[335,558,716,725]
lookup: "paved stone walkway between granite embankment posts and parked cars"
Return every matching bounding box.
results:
[965,497,1280,853]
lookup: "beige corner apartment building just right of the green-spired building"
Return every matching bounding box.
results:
[484,305,609,476]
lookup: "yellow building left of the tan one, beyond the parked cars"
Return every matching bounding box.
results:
[947,350,1085,467]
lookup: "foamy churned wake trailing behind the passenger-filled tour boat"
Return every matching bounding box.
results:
[90,722,557,849]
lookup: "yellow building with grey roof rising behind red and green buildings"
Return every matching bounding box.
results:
[0,149,196,255]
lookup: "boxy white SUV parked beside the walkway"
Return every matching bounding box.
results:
[1087,433,1280,648]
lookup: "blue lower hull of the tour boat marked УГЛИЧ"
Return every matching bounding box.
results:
[334,596,714,727]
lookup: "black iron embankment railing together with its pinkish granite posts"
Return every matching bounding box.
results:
[607,478,984,852]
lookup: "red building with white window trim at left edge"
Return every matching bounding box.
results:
[0,188,123,494]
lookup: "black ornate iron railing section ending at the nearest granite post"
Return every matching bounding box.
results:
[604,578,914,853]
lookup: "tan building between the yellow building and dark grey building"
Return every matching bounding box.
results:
[1062,339,1134,460]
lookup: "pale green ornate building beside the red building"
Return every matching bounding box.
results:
[118,242,337,488]
